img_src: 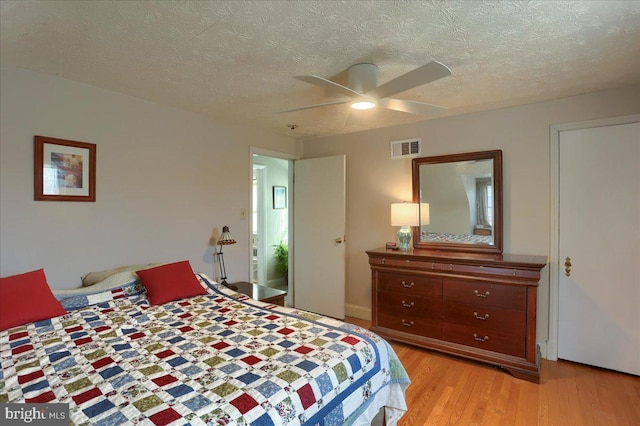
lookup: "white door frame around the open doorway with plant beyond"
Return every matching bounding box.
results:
[248,146,300,300]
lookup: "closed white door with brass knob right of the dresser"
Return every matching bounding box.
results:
[558,123,640,375]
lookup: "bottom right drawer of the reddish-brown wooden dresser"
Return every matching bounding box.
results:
[442,322,525,357]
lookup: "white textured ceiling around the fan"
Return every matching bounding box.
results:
[0,0,640,137]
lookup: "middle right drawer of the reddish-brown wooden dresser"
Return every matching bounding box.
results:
[444,301,527,336]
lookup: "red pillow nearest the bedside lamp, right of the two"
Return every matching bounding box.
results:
[136,260,207,305]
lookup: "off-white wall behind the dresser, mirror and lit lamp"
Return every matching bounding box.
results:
[303,86,640,350]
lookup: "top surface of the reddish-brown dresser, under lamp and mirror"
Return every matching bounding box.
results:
[367,247,547,269]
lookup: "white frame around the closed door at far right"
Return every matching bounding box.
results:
[543,114,640,361]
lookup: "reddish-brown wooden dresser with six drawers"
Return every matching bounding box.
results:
[367,248,546,383]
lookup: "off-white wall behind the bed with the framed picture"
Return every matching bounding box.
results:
[0,68,296,288]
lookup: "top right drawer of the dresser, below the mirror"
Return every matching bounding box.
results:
[443,279,527,311]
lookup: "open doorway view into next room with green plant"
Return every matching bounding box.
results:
[251,153,291,293]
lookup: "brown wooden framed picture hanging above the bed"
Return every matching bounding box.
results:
[34,136,96,202]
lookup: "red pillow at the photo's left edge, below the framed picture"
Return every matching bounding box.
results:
[0,269,67,330]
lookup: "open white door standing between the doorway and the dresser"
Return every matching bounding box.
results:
[293,155,346,319]
